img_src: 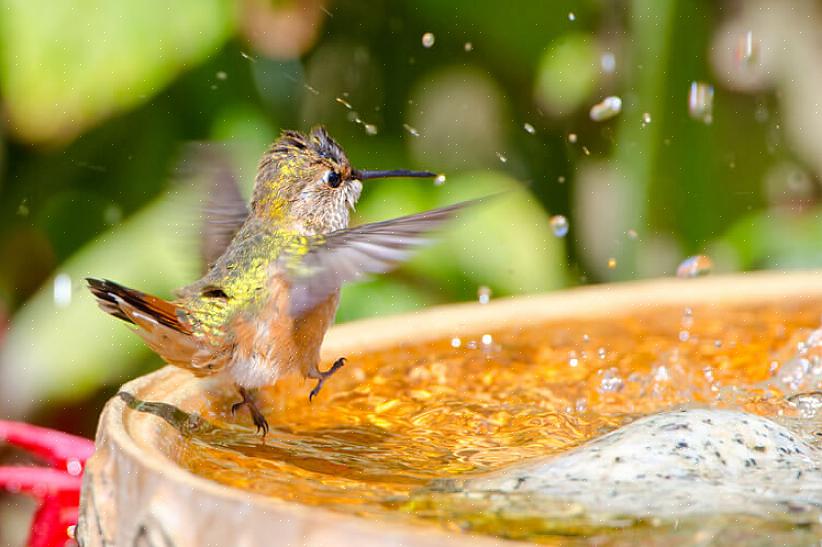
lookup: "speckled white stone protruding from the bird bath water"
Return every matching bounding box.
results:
[452,409,822,519]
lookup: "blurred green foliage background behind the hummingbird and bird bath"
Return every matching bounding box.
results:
[0,0,822,543]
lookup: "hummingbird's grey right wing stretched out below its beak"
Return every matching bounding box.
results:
[280,200,480,317]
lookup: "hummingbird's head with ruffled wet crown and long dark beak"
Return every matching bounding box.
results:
[251,127,436,235]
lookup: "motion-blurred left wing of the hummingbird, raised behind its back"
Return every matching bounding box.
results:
[197,148,249,271]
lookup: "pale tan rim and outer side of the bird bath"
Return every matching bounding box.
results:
[78,271,822,547]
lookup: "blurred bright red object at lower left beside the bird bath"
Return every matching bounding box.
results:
[0,420,94,547]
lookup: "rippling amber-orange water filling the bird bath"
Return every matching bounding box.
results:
[145,299,822,542]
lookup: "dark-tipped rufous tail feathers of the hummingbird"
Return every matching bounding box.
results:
[86,277,191,334]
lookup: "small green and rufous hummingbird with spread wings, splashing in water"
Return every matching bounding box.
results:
[87,127,470,436]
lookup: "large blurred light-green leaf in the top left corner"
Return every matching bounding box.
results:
[0,0,235,141]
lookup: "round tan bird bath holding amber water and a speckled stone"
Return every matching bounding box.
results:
[78,272,822,547]
